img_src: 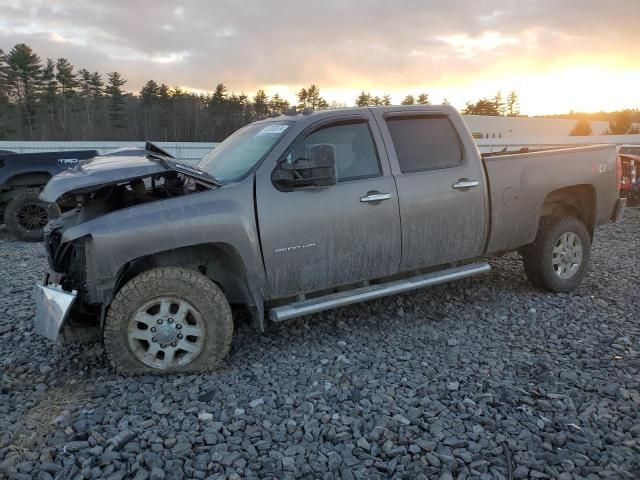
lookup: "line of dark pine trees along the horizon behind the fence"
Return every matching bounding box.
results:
[0,43,640,141]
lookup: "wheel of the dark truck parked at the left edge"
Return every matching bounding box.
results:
[4,192,60,242]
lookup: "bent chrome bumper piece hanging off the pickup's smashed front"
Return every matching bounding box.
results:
[33,275,78,342]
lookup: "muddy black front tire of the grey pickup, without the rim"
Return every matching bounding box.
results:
[103,268,233,375]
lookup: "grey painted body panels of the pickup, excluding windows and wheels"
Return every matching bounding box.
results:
[37,106,617,322]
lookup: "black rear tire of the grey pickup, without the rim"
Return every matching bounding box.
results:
[520,216,591,293]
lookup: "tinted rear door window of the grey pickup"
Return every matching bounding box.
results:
[386,117,464,173]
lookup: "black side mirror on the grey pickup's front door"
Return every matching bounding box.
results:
[271,143,337,190]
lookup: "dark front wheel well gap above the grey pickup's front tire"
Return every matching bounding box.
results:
[113,243,264,331]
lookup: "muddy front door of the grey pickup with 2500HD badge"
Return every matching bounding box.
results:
[256,117,401,298]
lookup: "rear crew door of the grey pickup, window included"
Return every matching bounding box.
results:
[372,112,488,271]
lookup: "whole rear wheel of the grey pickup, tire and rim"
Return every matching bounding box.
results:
[520,216,591,293]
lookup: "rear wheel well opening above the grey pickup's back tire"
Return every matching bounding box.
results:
[541,184,597,239]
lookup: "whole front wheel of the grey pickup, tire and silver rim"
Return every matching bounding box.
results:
[103,268,233,375]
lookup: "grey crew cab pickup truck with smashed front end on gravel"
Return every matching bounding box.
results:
[34,106,624,374]
